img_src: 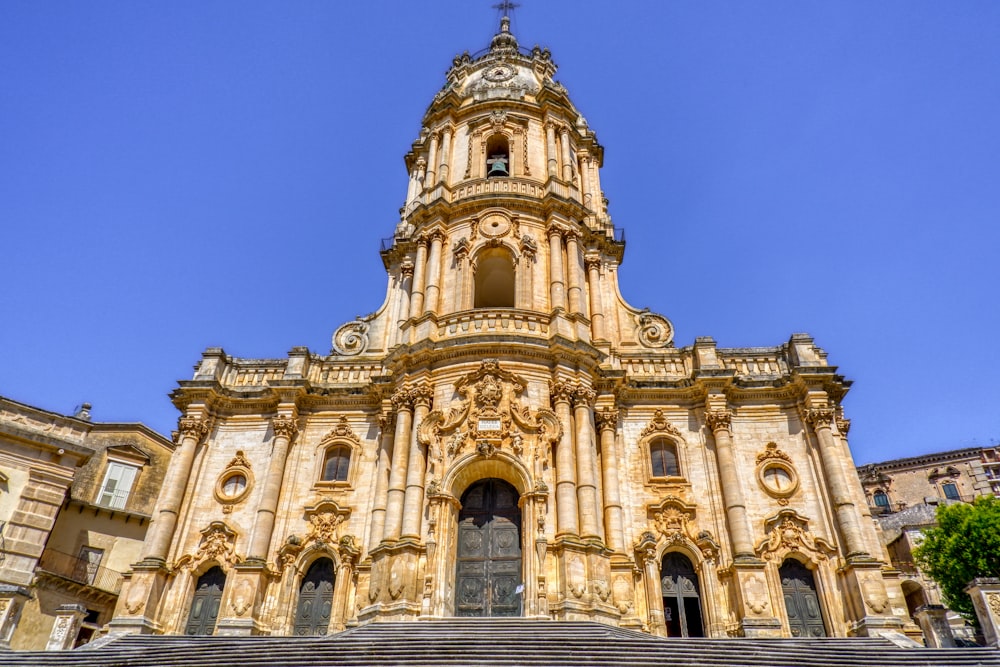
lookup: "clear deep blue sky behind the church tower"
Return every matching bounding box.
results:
[0,0,1000,463]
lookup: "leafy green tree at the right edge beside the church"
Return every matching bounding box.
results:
[913,496,1000,622]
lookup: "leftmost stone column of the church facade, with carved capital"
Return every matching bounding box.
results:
[141,417,209,561]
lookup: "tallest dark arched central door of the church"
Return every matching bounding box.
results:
[455,479,521,616]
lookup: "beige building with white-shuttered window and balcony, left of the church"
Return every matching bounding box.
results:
[0,397,173,650]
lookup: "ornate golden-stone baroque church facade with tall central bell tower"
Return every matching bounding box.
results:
[111,18,919,637]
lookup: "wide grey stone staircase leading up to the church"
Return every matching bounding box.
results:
[7,618,1000,667]
